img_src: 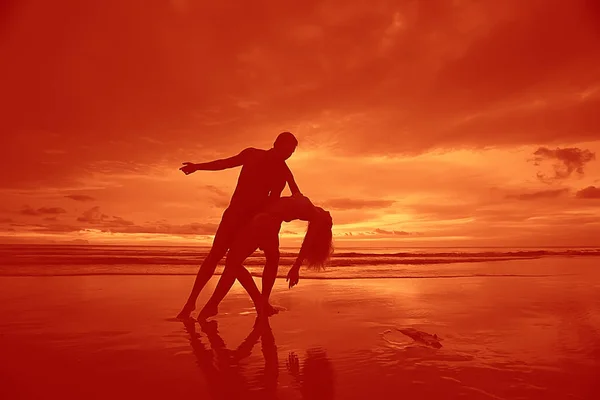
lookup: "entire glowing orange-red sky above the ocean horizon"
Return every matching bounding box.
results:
[0,0,600,246]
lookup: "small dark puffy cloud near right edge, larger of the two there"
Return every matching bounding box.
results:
[532,147,596,183]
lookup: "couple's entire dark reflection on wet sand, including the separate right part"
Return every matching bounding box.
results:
[184,319,334,400]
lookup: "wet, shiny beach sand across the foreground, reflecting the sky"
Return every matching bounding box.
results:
[0,275,600,400]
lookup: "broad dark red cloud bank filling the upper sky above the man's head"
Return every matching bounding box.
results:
[0,0,600,192]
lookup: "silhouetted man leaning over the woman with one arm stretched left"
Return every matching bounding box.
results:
[177,132,300,319]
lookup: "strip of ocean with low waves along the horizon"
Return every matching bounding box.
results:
[0,244,600,279]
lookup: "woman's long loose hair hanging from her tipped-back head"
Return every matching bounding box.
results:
[300,208,333,270]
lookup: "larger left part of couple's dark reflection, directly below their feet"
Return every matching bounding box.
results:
[184,319,279,399]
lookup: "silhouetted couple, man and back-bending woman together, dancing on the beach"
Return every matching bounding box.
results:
[177,132,333,321]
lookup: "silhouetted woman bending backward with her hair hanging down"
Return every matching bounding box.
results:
[198,195,333,320]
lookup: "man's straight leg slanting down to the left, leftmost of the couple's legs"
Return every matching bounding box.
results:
[177,210,239,319]
